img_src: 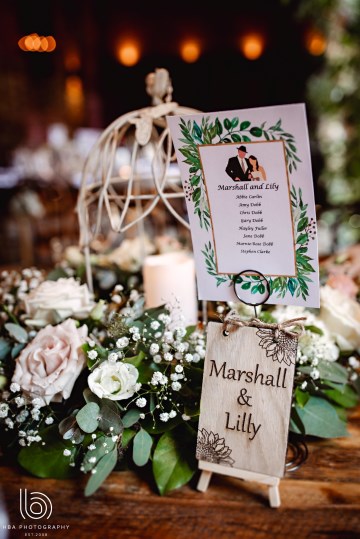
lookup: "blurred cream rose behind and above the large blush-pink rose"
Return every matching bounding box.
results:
[23,277,95,327]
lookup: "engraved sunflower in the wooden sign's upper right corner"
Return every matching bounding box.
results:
[256,328,298,367]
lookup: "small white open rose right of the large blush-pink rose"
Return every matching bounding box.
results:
[88,361,139,400]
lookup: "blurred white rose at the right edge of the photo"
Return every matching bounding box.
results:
[319,286,360,350]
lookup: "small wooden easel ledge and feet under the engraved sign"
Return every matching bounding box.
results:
[196,460,281,507]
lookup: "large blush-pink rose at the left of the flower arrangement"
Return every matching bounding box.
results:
[12,318,87,404]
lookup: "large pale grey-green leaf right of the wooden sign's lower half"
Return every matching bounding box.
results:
[296,396,348,438]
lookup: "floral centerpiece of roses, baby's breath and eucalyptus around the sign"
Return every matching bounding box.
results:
[0,269,360,495]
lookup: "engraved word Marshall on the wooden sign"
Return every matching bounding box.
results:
[210,359,287,389]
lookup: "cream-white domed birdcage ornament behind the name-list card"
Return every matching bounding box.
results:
[77,69,199,290]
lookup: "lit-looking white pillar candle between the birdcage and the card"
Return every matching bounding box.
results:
[143,252,198,325]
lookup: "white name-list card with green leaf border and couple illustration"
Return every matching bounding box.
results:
[167,104,319,307]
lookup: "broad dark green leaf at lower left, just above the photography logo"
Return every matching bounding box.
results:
[18,425,76,479]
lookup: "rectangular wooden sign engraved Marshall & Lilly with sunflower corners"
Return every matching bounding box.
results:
[196,322,297,506]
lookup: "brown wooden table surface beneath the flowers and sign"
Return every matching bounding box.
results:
[0,410,360,539]
